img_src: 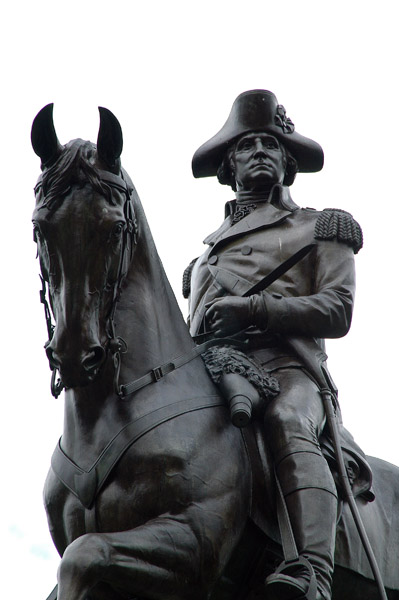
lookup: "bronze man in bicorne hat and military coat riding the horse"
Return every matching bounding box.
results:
[185,90,370,600]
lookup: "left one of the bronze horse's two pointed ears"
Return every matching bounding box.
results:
[31,104,62,169]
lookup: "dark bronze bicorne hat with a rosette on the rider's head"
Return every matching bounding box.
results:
[192,90,324,177]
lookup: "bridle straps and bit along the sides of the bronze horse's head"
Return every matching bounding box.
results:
[35,170,137,398]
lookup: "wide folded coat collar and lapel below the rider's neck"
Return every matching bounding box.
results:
[204,184,299,245]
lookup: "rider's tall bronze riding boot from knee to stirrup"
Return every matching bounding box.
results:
[266,452,337,600]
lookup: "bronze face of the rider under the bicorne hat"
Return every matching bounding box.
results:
[231,133,285,191]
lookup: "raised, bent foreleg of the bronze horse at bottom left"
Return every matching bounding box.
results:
[58,516,220,600]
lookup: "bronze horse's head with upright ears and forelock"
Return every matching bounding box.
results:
[32,104,135,388]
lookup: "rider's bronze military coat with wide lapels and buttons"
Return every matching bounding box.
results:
[189,185,361,360]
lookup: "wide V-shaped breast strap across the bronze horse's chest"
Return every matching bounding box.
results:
[51,396,224,508]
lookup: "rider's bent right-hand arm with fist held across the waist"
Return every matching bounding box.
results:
[206,240,355,338]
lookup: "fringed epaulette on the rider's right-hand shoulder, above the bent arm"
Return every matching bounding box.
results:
[314,208,363,254]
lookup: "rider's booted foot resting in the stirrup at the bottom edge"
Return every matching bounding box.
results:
[265,556,317,600]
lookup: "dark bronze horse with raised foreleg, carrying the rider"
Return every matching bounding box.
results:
[32,106,399,600]
